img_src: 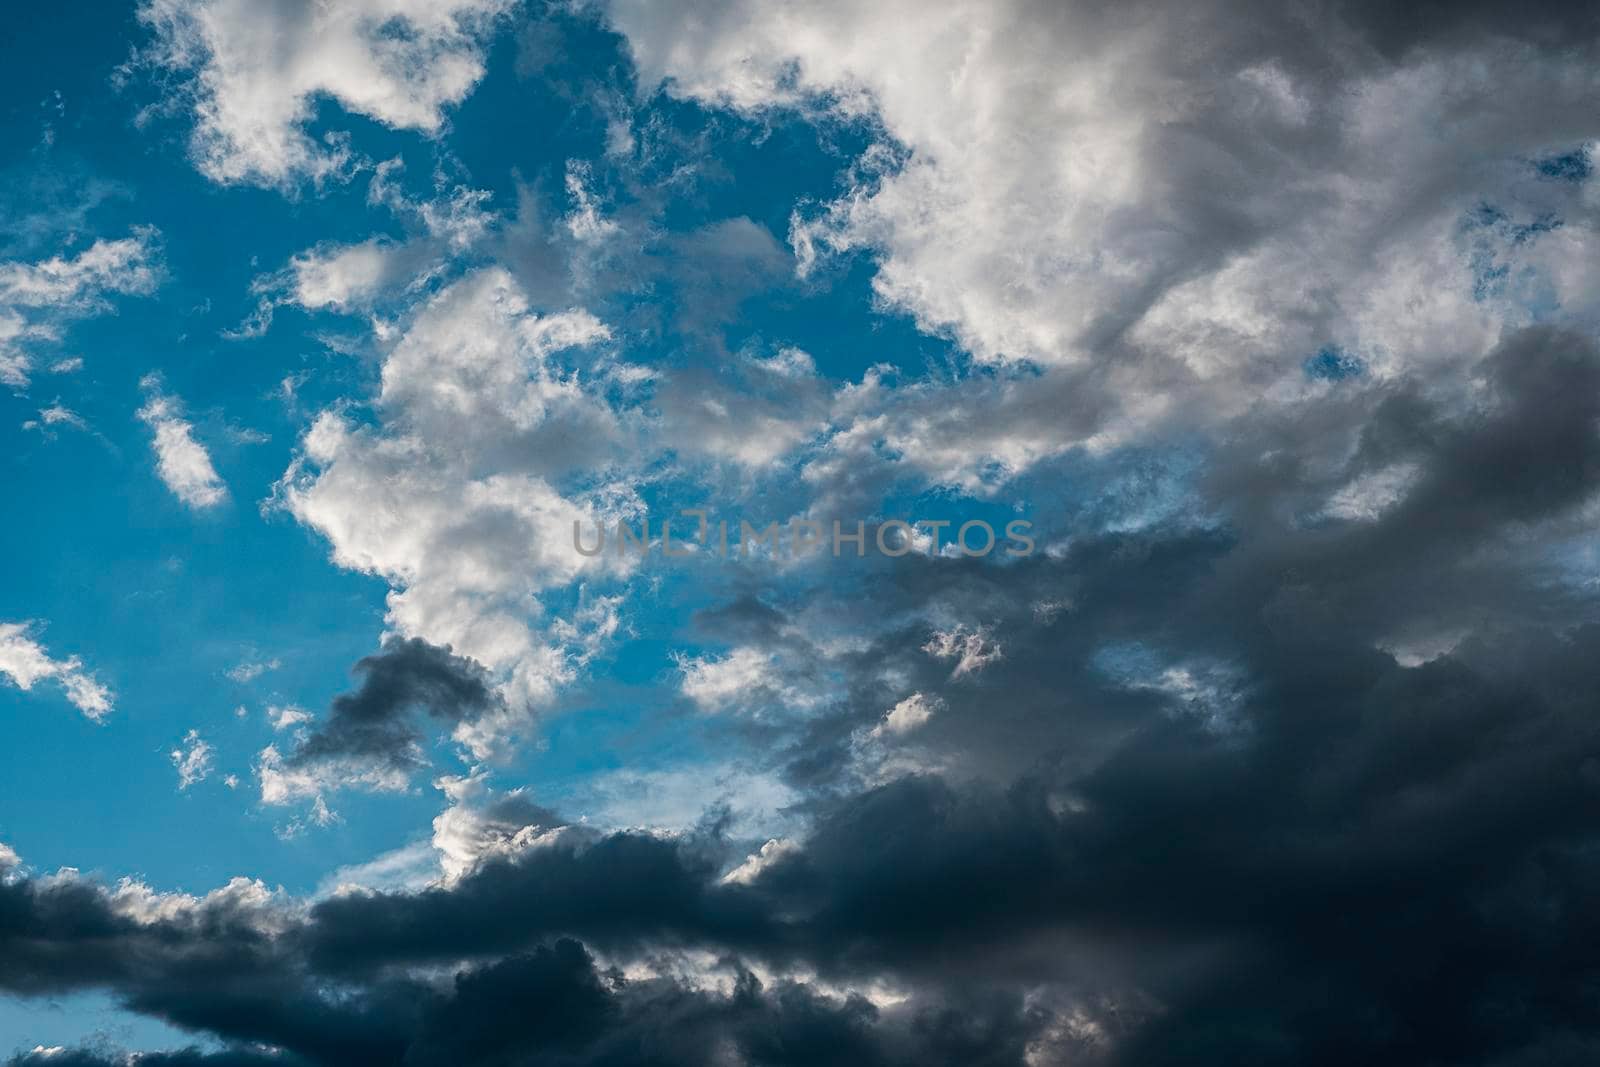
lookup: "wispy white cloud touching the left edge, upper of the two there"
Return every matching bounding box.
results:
[0,227,162,389]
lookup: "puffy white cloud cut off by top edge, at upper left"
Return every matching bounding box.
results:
[139,0,514,186]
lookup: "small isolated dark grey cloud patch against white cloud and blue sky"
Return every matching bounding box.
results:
[290,638,499,769]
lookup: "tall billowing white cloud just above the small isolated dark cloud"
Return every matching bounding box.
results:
[277,269,637,755]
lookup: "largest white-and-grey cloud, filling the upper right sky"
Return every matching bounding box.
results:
[605,0,1600,444]
